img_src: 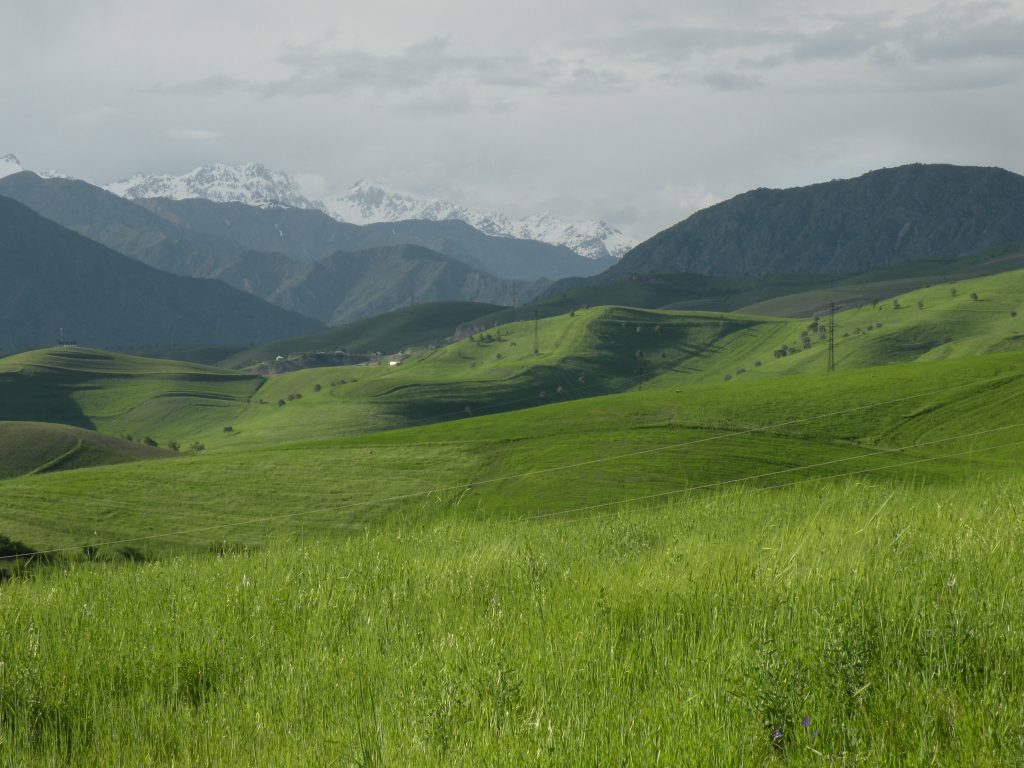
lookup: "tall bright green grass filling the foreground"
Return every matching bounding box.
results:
[0,477,1024,766]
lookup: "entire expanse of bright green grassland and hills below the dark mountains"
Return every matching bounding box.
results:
[0,271,1024,766]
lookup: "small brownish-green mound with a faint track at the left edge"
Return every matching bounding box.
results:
[0,422,173,479]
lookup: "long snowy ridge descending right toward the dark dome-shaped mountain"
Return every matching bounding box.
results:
[323,181,636,259]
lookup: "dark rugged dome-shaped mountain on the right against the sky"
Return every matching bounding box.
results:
[597,165,1024,283]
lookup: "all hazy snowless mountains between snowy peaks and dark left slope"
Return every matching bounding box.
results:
[0,172,552,324]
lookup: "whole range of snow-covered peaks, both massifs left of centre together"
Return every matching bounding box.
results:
[104,163,636,262]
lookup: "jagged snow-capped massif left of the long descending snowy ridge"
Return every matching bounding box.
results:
[104,163,319,208]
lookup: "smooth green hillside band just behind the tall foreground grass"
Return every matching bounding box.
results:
[0,352,1024,550]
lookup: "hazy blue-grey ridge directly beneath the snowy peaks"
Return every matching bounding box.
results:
[135,198,616,281]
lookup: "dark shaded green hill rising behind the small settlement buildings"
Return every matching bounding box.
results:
[221,301,501,368]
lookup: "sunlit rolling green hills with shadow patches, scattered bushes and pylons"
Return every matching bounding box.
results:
[0,270,1024,450]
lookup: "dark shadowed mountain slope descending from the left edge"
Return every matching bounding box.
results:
[0,197,323,351]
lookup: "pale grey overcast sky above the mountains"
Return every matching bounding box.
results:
[0,0,1024,239]
